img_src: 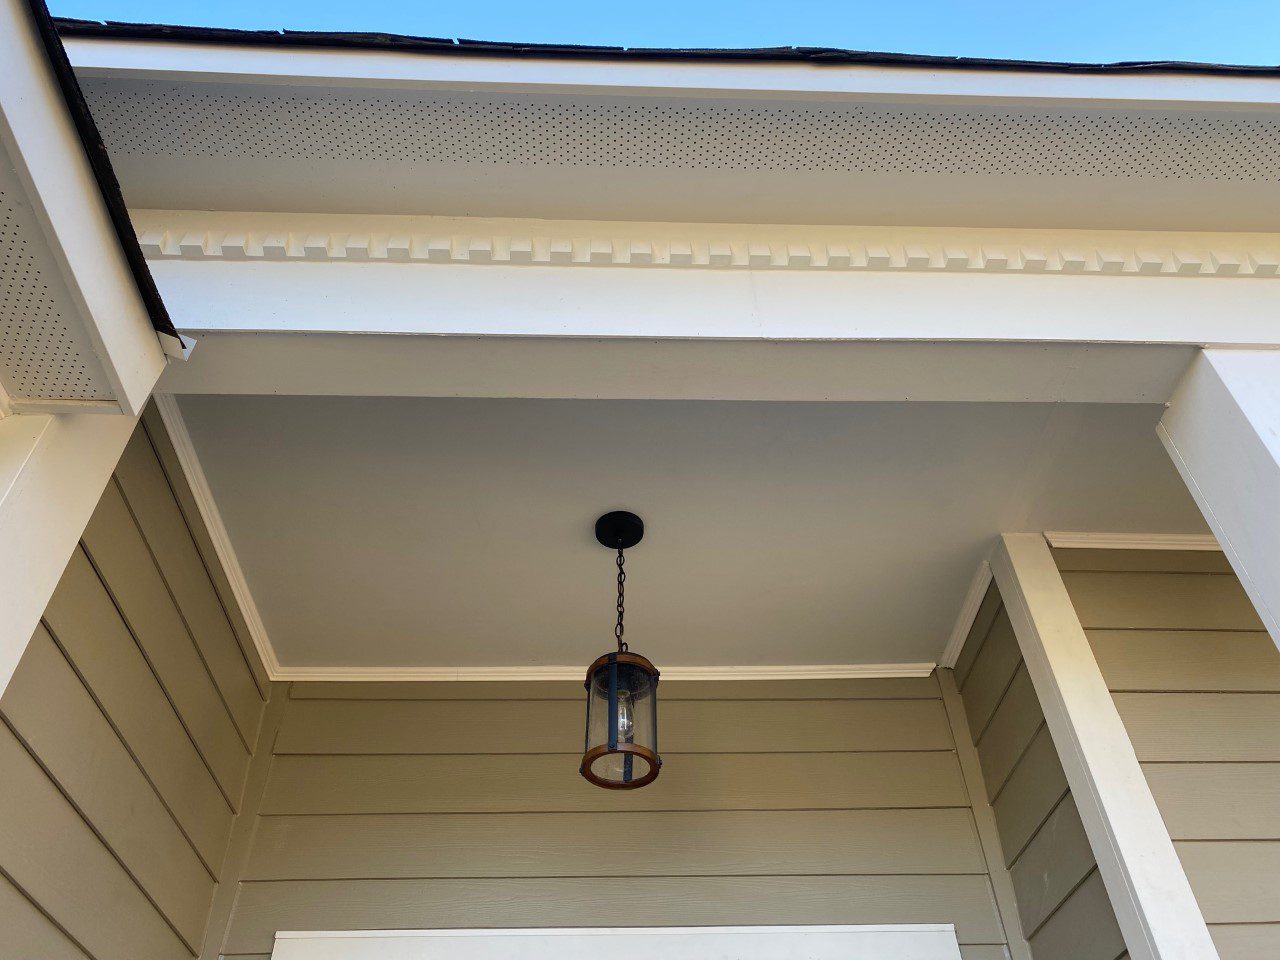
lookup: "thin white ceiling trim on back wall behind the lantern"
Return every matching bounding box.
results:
[273,658,937,682]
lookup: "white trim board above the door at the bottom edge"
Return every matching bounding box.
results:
[271,923,960,960]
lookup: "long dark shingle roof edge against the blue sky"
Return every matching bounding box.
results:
[55,17,1280,77]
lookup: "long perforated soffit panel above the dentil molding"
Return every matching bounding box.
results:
[84,77,1280,230]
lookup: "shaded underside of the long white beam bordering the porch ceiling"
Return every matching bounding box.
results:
[160,332,1193,403]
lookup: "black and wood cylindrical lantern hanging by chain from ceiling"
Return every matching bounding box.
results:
[579,511,662,790]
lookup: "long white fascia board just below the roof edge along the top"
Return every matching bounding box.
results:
[67,37,1280,109]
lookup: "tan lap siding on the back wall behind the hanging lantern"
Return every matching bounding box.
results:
[223,677,1005,960]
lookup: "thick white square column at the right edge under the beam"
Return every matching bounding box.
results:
[1158,349,1280,645]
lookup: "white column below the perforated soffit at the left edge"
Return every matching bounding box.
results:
[0,413,137,691]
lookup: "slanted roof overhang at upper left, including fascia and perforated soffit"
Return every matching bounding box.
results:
[0,0,173,415]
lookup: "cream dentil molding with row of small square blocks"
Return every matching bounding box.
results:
[133,210,1280,279]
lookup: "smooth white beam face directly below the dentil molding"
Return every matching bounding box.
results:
[151,260,1280,346]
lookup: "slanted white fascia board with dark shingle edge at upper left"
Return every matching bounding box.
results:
[0,0,165,416]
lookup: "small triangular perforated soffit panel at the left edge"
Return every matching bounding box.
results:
[0,144,115,403]
